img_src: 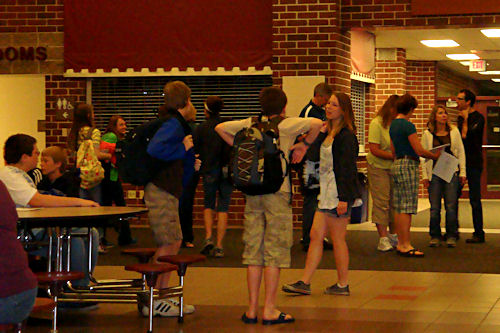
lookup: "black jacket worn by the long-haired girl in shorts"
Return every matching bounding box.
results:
[311,127,361,204]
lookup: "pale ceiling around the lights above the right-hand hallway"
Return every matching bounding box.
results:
[374,28,500,82]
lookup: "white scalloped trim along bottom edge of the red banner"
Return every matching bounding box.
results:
[64,66,273,77]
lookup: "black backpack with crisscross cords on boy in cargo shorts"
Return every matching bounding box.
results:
[229,116,288,195]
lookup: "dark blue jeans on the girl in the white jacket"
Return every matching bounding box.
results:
[429,173,459,238]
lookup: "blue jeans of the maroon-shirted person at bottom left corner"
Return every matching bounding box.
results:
[0,288,38,324]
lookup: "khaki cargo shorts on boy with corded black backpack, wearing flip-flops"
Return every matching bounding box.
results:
[243,192,293,268]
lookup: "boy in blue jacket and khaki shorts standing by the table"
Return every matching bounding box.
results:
[142,81,199,317]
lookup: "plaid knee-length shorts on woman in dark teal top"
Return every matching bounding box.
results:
[391,159,419,214]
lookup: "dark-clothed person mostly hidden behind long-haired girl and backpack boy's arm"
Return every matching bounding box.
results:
[299,82,333,252]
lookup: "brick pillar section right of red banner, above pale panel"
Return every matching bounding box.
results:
[272,0,351,92]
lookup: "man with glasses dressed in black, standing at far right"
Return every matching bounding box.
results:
[457,89,484,244]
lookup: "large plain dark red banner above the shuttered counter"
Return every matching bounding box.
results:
[64,0,272,72]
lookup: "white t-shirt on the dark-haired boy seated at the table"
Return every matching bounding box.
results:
[0,165,37,207]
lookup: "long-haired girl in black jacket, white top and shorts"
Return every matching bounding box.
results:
[283,93,361,295]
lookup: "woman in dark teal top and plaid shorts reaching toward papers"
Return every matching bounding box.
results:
[389,94,441,257]
